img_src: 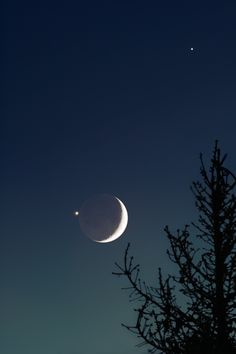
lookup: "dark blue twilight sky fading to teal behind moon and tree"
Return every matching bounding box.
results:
[0,0,236,354]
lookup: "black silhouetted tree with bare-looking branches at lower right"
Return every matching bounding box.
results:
[113,142,236,354]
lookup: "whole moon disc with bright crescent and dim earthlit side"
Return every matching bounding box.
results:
[77,194,128,243]
